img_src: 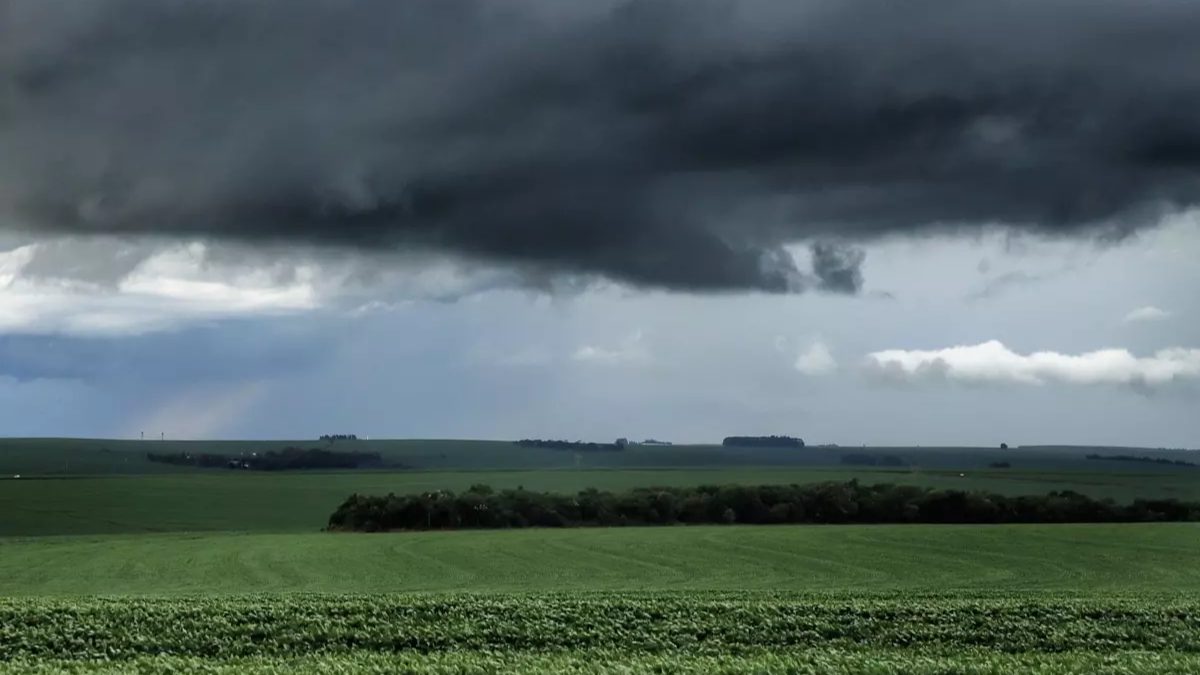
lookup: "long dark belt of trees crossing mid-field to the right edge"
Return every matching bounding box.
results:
[329,480,1200,532]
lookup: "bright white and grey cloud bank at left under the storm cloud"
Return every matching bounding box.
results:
[0,238,525,336]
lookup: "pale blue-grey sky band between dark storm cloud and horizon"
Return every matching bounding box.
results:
[0,210,1200,447]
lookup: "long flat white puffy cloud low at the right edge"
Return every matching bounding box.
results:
[866,340,1200,387]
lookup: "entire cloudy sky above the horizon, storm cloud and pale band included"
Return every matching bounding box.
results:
[0,0,1200,447]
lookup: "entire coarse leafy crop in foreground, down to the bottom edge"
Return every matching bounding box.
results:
[0,593,1200,673]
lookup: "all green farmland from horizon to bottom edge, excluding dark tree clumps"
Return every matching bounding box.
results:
[7,440,1200,674]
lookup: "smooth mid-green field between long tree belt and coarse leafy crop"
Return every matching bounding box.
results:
[0,524,1200,596]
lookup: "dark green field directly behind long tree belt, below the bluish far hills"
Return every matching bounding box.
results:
[7,467,1200,536]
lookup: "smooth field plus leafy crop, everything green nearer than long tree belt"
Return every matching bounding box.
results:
[0,524,1200,675]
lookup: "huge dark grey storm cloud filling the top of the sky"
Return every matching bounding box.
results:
[0,0,1200,291]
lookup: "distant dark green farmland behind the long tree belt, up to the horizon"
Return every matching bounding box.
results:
[7,438,1200,536]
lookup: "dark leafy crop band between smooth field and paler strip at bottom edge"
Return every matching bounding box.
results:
[0,593,1200,661]
